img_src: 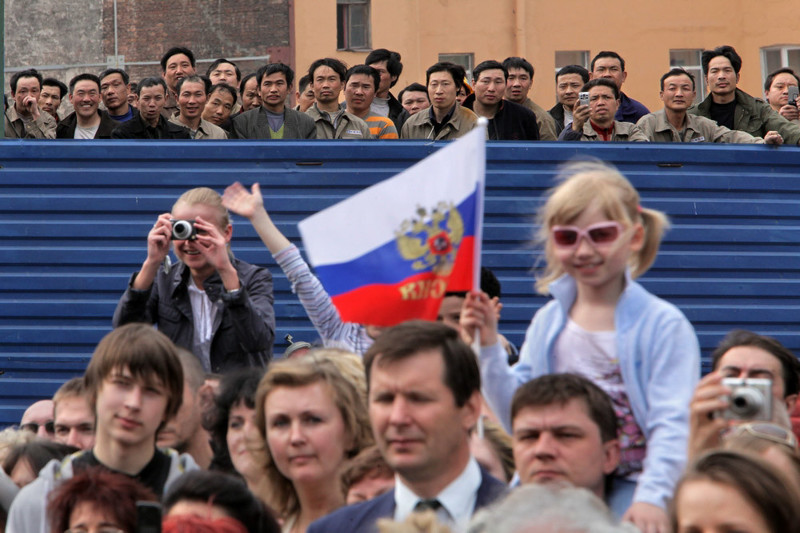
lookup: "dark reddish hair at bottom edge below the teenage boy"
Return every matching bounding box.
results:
[47,466,158,532]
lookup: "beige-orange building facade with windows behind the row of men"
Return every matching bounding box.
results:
[293,0,800,110]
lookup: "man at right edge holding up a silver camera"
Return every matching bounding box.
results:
[689,330,800,459]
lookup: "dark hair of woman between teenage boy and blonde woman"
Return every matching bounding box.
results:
[203,368,264,474]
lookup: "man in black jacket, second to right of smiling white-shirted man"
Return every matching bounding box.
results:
[111,78,191,139]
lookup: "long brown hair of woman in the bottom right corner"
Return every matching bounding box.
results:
[670,451,800,533]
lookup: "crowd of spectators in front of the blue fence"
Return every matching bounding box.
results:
[0,156,800,533]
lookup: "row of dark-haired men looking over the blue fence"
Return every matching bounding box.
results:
[5,46,800,145]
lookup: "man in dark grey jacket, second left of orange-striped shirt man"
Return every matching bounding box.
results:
[233,63,317,139]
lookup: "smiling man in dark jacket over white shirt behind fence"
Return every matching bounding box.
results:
[56,74,119,139]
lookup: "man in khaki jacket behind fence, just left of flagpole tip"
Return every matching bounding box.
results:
[401,62,478,141]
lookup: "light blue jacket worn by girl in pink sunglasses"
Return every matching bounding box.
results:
[480,273,700,507]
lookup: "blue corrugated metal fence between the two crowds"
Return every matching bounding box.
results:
[0,141,800,426]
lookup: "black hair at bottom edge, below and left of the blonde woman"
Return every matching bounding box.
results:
[164,470,280,533]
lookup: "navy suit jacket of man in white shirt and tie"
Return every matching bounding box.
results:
[307,468,508,533]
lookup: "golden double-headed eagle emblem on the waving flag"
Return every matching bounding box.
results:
[395,202,464,276]
